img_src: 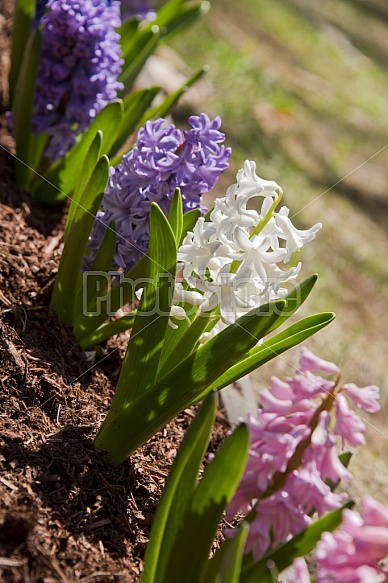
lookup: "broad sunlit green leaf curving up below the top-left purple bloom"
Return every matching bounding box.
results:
[32,100,123,206]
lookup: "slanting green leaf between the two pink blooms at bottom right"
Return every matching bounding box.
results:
[240,500,354,583]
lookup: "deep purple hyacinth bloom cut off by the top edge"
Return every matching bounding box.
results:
[32,0,123,161]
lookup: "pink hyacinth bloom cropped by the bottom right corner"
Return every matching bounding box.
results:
[293,496,388,583]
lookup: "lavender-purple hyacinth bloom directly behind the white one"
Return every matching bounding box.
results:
[85,113,231,271]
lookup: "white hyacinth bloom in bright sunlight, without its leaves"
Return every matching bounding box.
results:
[178,161,321,324]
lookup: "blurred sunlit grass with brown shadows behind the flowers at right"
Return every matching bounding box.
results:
[172,0,388,501]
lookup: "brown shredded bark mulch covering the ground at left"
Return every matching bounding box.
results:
[0,1,226,583]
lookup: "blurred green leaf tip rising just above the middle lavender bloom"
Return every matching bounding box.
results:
[109,87,160,156]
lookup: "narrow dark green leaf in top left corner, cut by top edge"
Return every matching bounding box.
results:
[9,0,35,109]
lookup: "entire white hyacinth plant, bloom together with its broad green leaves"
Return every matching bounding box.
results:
[91,162,333,463]
